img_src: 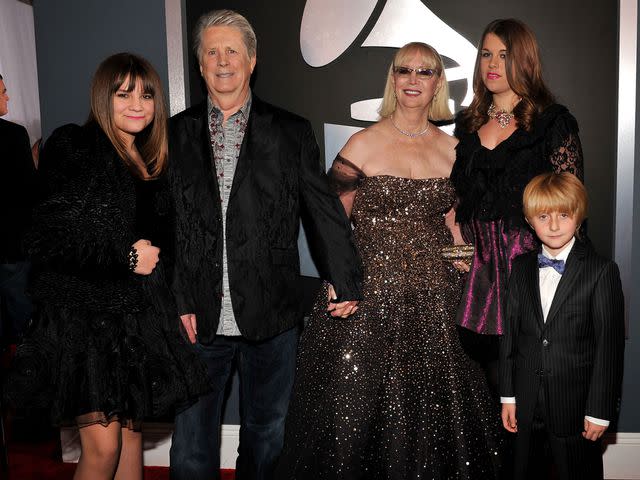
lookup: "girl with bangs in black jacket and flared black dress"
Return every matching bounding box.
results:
[4,53,206,479]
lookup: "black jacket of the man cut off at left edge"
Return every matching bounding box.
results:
[0,119,36,263]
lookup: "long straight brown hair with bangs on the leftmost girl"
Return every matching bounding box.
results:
[89,53,169,178]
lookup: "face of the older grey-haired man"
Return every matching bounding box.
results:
[200,26,256,103]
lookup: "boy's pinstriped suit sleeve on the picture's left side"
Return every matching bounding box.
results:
[499,261,521,401]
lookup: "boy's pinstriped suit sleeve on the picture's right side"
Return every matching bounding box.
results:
[585,262,624,420]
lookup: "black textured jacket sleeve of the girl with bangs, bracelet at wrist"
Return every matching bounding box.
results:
[25,126,135,272]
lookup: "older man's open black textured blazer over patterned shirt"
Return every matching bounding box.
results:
[169,95,361,344]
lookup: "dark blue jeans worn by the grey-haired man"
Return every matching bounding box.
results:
[170,328,299,480]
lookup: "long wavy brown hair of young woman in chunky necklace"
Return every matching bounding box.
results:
[459,18,555,132]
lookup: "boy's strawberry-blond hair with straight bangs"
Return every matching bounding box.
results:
[522,172,589,225]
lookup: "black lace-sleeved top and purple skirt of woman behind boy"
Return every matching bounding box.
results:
[451,104,582,335]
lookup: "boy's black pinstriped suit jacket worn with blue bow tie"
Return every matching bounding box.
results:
[500,239,624,435]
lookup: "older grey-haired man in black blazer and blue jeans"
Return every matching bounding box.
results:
[169,10,362,480]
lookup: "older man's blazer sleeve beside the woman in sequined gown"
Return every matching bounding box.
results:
[299,122,362,301]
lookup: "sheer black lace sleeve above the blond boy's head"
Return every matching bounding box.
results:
[547,112,584,181]
